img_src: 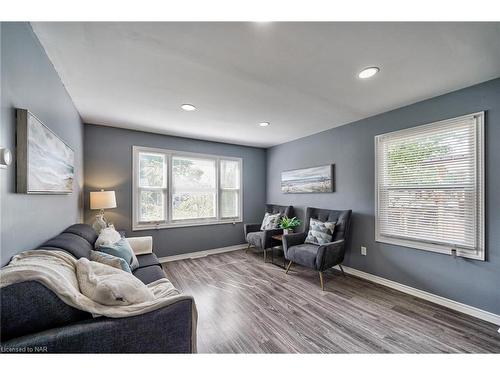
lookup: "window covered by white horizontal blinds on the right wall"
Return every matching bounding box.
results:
[375,112,484,260]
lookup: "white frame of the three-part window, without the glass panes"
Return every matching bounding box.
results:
[132,146,243,231]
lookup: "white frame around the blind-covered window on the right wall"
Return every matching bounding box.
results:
[375,112,485,261]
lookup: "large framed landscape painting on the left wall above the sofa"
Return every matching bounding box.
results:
[17,109,74,194]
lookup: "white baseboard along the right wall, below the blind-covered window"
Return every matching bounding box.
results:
[336,266,500,333]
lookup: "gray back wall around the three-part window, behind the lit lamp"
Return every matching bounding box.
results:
[84,125,266,257]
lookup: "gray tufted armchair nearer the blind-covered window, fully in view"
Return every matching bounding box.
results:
[283,207,352,290]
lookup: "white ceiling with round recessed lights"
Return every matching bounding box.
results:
[32,22,500,147]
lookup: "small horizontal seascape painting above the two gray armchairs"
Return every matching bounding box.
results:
[281,164,333,193]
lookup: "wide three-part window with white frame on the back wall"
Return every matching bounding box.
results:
[133,146,242,230]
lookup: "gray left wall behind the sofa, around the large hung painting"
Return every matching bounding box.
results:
[0,22,83,265]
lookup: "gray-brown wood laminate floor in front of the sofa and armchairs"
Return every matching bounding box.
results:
[163,249,500,353]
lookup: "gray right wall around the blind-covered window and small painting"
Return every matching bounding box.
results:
[267,79,500,314]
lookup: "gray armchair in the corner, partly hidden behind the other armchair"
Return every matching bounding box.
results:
[244,204,293,262]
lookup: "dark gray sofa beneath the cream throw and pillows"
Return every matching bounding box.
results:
[0,224,195,353]
